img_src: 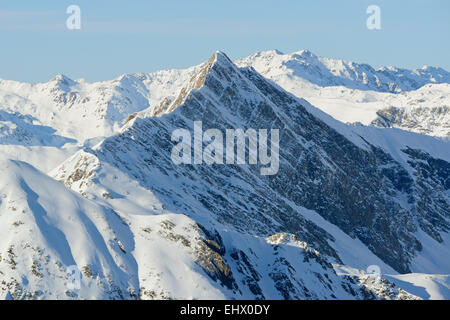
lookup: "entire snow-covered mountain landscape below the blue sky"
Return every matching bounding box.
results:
[0,51,450,299]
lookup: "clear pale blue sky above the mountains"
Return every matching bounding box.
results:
[0,0,450,82]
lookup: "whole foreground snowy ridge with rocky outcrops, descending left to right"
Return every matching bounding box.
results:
[0,161,422,299]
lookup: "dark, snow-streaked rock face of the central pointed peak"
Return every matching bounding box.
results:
[54,53,450,273]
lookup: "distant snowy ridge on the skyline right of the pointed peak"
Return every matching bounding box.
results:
[236,50,450,93]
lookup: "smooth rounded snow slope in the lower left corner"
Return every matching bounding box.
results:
[0,161,138,299]
